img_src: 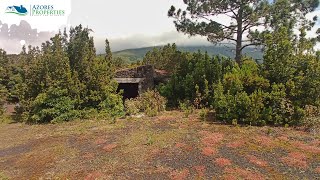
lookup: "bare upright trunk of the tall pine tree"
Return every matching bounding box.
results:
[235,6,243,65]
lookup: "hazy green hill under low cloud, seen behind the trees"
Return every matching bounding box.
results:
[113,44,262,62]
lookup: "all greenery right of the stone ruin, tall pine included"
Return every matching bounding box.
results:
[159,0,320,126]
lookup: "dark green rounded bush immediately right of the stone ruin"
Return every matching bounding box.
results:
[158,52,234,108]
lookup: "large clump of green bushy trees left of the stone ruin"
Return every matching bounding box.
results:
[3,25,124,123]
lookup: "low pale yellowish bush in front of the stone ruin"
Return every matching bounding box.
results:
[125,90,167,116]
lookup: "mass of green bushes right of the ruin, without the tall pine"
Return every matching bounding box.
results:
[159,19,320,126]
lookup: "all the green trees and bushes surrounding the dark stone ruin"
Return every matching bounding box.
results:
[0,0,320,130]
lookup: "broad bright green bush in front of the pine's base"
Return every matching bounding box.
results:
[214,61,312,125]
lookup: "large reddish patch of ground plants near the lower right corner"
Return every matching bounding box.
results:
[281,152,308,169]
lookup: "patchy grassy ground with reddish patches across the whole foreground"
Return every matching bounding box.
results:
[0,111,320,179]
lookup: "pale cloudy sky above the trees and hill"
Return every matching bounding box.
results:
[0,0,320,53]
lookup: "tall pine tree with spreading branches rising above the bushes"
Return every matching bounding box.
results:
[168,0,319,64]
